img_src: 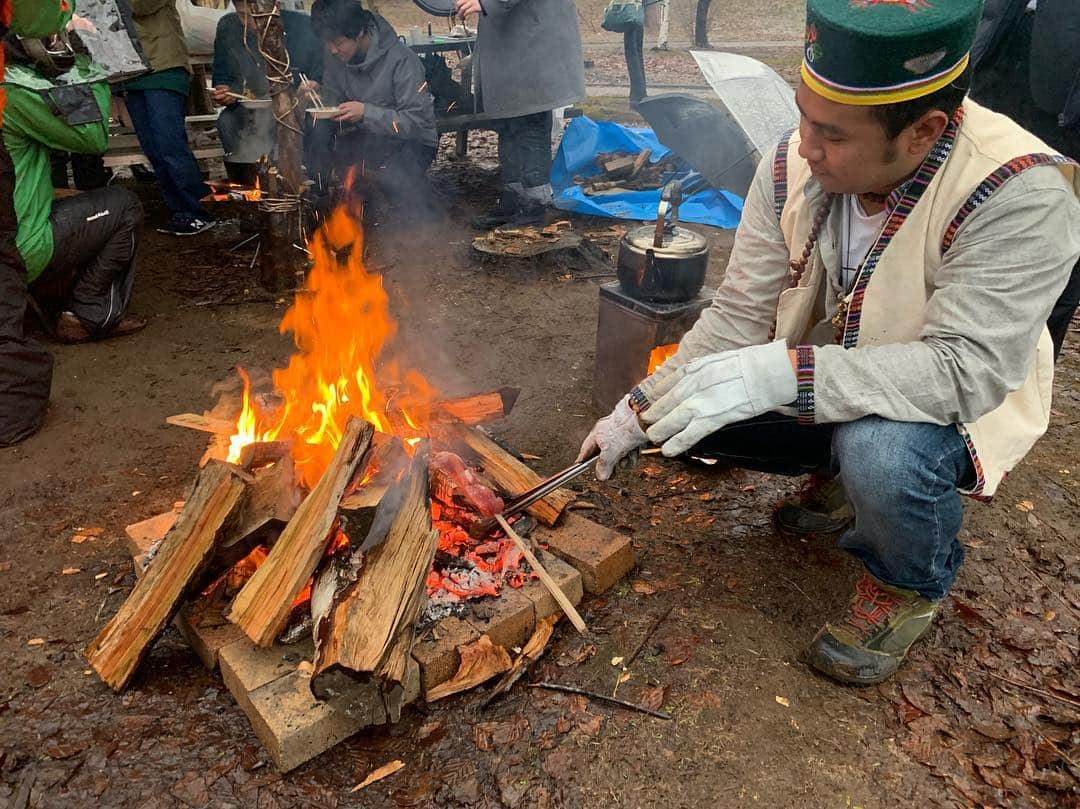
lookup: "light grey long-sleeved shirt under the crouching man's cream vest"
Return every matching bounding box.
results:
[642,151,1080,424]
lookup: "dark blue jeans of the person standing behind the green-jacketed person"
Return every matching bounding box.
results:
[126,90,210,218]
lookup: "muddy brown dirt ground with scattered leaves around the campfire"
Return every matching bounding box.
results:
[0,3,1080,809]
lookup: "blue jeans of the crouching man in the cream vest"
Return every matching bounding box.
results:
[689,414,975,599]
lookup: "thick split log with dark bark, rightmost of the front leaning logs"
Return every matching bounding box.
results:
[311,443,438,713]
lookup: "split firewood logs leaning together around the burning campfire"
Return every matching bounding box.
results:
[86,389,571,697]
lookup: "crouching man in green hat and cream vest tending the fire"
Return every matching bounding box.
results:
[581,0,1080,685]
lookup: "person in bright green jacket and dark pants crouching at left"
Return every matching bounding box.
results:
[3,33,146,342]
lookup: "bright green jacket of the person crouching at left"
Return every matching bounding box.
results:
[3,56,109,282]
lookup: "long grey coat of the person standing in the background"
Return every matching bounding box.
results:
[476,0,585,118]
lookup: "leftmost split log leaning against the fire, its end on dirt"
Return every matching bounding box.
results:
[85,462,244,690]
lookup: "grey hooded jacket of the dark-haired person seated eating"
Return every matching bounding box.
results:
[320,14,438,146]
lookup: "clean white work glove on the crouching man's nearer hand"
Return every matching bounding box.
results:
[642,340,798,458]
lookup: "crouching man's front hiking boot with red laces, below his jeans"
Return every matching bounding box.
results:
[807,574,941,686]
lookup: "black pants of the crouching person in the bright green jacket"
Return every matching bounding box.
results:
[33,188,143,334]
